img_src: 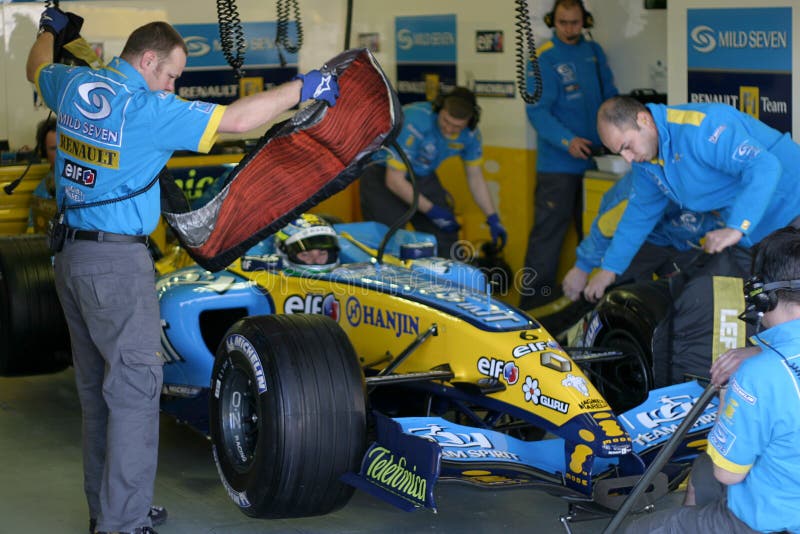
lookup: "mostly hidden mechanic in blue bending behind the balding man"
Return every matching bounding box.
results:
[562,172,722,301]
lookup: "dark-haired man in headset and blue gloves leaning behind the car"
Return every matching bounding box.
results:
[360,87,507,257]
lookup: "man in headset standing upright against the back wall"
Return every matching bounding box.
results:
[520,0,617,309]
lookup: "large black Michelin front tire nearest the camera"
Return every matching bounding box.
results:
[209,315,366,518]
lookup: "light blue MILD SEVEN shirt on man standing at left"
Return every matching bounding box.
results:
[35,58,224,235]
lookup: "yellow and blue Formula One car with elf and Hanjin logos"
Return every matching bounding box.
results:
[0,223,716,528]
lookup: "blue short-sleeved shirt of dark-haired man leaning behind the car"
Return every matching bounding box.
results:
[374,102,483,177]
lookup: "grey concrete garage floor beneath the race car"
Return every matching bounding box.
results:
[0,369,682,534]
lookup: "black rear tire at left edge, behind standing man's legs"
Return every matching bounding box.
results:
[0,235,70,376]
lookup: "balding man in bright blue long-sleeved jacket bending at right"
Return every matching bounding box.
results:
[584,96,800,300]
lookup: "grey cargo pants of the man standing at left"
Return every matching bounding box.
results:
[55,240,163,532]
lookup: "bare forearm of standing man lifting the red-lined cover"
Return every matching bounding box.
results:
[217,80,303,133]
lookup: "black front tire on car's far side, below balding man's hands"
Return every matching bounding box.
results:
[587,280,672,413]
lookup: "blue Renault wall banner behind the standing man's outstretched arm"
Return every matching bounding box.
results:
[175,22,297,104]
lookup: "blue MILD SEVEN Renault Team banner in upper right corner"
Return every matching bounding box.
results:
[687,7,792,133]
